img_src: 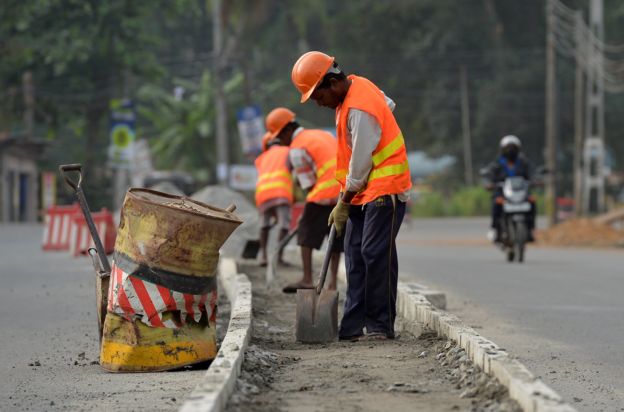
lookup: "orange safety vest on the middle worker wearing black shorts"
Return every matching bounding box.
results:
[290,129,340,203]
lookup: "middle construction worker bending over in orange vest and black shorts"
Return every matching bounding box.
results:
[266,107,343,293]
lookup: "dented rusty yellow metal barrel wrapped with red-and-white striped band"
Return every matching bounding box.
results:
[100,188,242,372]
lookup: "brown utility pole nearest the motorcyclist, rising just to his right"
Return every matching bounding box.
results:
[545,0,557,226]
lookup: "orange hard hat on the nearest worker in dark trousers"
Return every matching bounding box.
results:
[291,51,334,103]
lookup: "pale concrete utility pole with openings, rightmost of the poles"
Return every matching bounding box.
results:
[583,0,605,213]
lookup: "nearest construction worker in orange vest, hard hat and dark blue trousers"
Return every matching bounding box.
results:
[292,51,412,341]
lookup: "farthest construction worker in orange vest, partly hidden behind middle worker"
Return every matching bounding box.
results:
[255,133,293,266]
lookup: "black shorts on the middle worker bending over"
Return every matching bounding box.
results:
[297,202,344,253]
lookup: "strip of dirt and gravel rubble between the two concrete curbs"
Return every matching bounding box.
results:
[226,258,520,412]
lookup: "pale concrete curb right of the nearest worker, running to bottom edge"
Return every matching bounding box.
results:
[397,282,576,412]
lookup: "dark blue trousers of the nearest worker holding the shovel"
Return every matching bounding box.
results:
[339,195,405,338]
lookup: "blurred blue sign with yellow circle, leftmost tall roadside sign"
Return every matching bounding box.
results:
[108,99,136,169]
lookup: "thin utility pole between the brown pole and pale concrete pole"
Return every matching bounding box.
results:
[574,10,587,217]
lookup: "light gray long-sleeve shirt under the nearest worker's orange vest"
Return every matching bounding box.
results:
[346,95,410,202]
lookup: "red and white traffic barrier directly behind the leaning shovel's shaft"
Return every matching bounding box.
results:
[69,208,117,256]
